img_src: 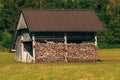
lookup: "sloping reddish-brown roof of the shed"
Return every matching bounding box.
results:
[22,9,104,32]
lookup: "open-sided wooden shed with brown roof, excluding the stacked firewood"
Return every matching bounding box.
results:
[10,9,104,62]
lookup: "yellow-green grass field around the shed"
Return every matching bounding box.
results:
[0,49,120,80]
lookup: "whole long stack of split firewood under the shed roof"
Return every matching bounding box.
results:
[34,42,98,62]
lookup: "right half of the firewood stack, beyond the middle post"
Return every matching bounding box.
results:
[68,43,98,62]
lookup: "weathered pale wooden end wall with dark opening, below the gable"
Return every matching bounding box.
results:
[16,29,32,62]
